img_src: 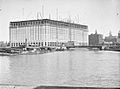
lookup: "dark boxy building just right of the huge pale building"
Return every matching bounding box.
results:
[89,31,103,45]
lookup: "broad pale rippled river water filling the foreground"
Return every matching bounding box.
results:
[0,49,120,87]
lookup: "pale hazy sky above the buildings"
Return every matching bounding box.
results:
[0,0,120,41]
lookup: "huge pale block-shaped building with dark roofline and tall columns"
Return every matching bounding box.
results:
[9,19,88,47]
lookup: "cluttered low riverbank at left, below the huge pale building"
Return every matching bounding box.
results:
[0,47,56,56]
